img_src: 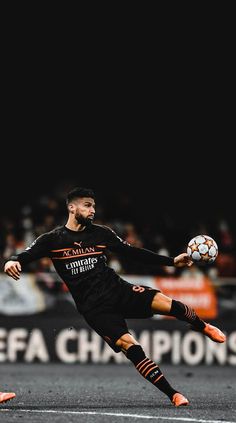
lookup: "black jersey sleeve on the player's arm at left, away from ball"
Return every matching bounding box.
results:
[6,233,50,265]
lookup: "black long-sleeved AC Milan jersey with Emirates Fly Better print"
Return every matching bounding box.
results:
[8,224,174,313]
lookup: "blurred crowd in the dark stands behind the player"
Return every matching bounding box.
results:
[0,187,236,278]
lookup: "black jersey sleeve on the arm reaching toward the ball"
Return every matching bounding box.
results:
[102,227,174,266]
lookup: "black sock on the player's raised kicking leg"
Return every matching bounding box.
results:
[170,300,205,331]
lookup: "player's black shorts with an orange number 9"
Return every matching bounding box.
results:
[83,282,160,352]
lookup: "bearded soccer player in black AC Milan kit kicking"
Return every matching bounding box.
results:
[4,187,226,407]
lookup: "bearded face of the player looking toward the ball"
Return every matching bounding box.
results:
[74,197,95,226]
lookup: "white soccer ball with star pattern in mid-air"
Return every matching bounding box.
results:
[187,235,218,263]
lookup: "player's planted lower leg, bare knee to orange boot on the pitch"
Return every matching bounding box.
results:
[116,333,189,407]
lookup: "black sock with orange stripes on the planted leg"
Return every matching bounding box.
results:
[126,345,177,400]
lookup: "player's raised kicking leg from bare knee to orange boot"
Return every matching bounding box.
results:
[151,292,226,342]
